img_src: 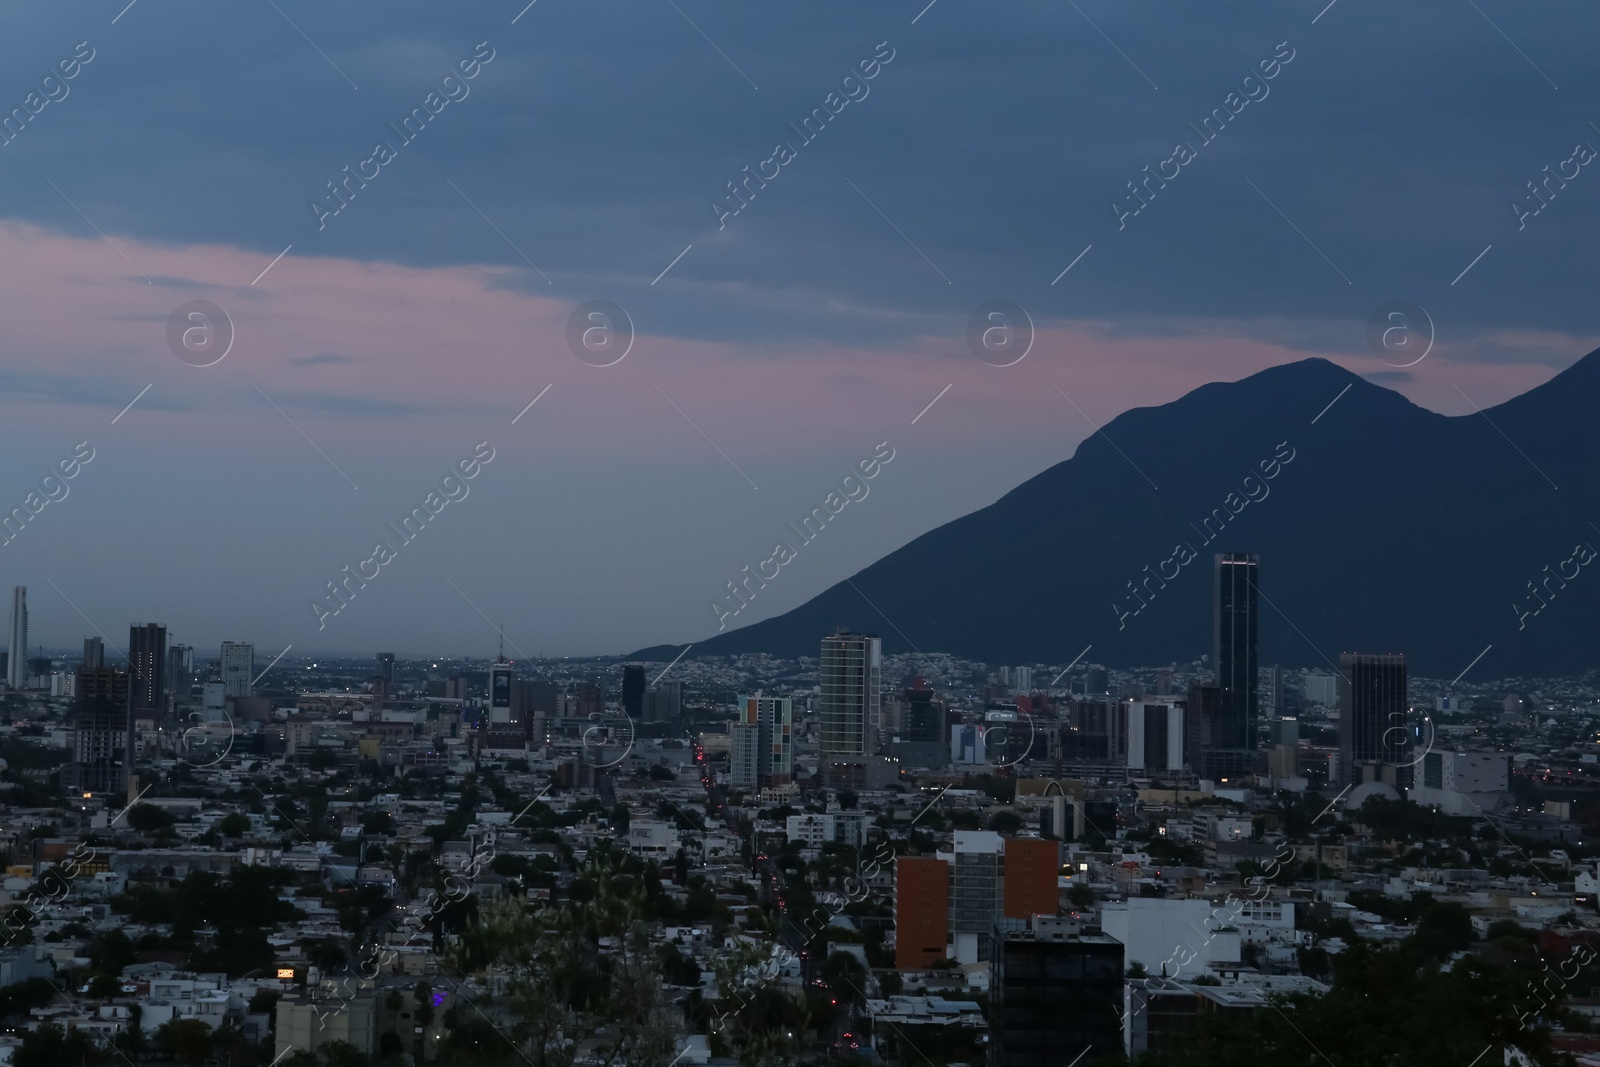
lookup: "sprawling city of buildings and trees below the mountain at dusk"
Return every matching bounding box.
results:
[0,552,1600,1067]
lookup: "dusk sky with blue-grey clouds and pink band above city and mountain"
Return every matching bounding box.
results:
[0,0,1600,656]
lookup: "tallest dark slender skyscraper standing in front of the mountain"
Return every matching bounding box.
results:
[1202,552,1259,774]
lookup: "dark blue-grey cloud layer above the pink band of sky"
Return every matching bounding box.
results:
[0,0,1600,344]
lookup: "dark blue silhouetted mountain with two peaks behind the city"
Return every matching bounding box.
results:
[635,350,1600,678]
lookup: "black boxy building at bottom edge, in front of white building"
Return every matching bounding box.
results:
[989,917,1123,1067]
